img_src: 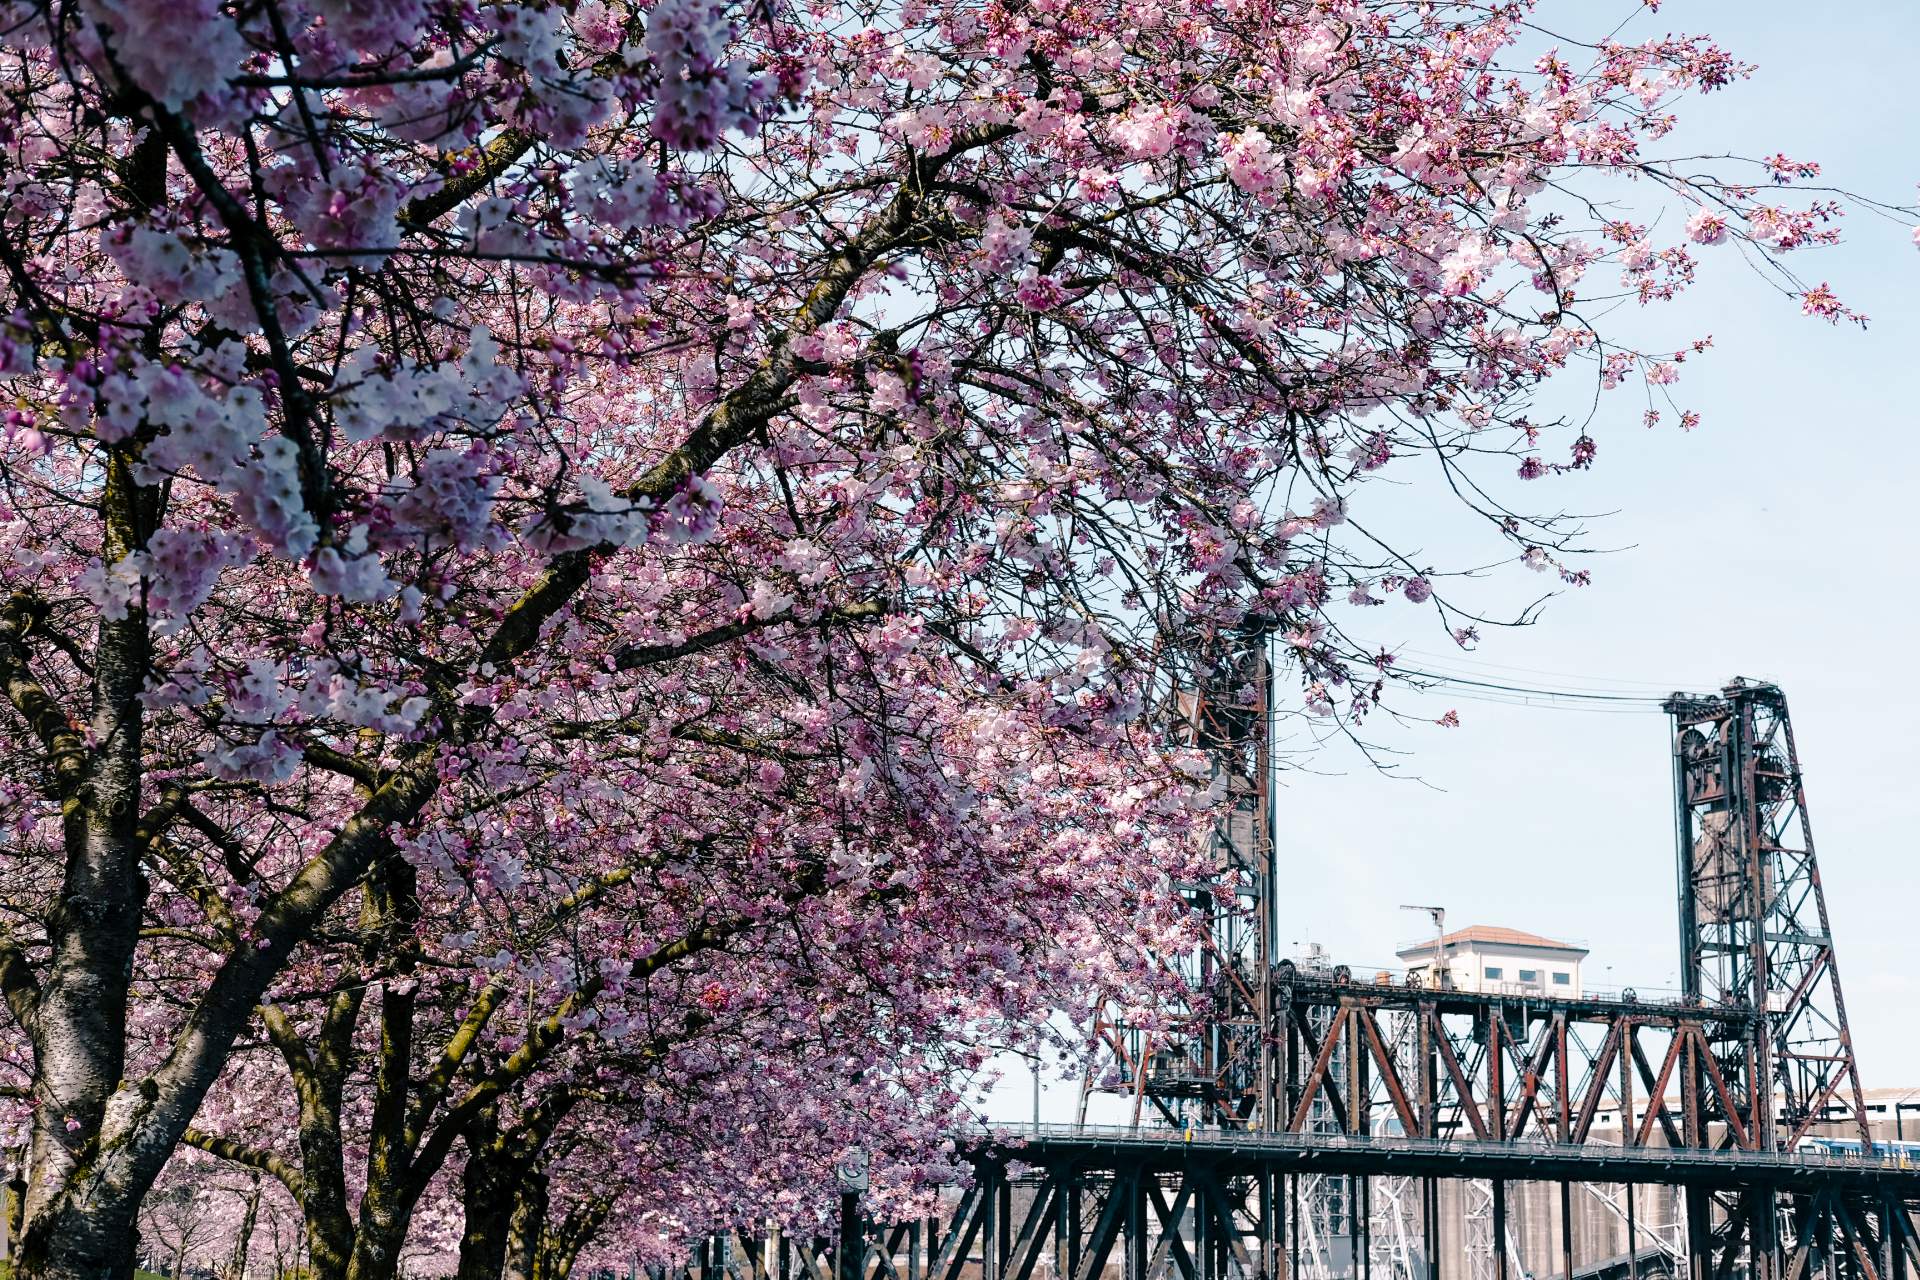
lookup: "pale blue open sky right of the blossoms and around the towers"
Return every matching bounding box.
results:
[993,0,1920,1119]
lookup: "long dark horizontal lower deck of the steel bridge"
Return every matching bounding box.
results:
[975,1125,1920,1201]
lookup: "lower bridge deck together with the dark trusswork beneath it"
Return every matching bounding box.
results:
[679,1125,1920,1280]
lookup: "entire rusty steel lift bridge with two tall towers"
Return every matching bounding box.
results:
[657,660,1920,1280]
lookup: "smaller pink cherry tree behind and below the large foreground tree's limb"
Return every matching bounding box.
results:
[168,690,1196,1276]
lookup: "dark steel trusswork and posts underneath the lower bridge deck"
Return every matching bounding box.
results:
[649,1142,1920,1280]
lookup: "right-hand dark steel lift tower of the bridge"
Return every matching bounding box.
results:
[1665,679,1891,1280]
